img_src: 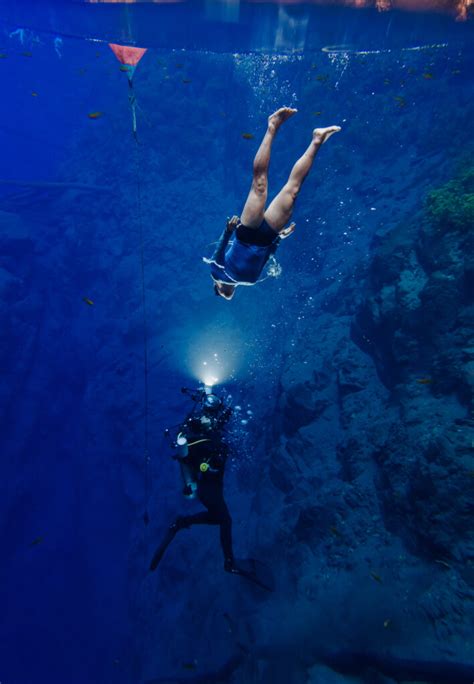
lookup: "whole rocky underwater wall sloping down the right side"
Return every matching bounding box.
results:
[246,163,474,681]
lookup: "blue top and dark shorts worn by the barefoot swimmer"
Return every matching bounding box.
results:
[205,221,280,285]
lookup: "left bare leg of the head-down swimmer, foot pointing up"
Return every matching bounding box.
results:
[240,107,297,228]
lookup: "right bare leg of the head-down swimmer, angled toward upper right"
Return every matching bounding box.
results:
[262,126,341,233]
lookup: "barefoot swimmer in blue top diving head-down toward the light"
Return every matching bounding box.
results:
[204,107,341,300]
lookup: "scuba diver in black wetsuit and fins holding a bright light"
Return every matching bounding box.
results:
[150,387,273,591]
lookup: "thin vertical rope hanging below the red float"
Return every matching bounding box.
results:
[129,87,150,525]
